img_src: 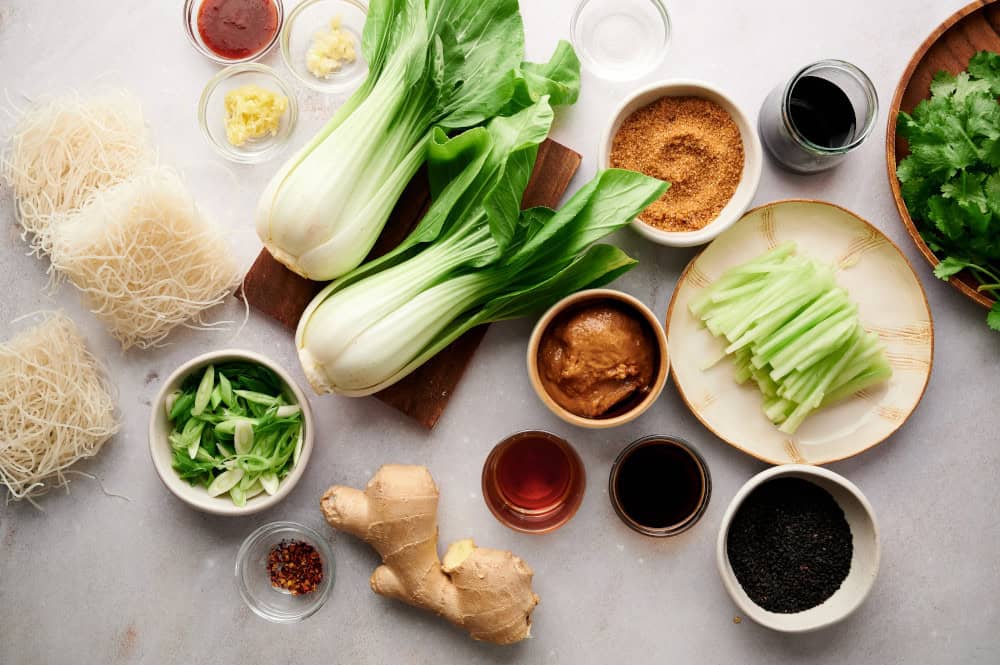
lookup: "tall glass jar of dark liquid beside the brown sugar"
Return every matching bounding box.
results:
[758,60,878,173]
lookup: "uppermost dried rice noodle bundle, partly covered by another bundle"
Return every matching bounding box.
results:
[0,90,155,253]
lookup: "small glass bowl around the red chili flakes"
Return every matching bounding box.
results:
[236,522,334,623]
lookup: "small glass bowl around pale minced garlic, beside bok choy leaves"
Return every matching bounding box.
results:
[281,0,368,93]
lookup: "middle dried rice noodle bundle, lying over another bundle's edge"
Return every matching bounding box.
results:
[50,166,240,349]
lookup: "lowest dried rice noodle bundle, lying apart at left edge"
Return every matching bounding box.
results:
[0,312,120,500]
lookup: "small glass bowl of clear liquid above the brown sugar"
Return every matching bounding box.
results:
[570,0,671,81]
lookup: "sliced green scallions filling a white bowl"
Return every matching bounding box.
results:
[168,362,302,506]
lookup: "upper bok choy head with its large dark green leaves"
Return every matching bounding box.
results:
[256,0,580,281]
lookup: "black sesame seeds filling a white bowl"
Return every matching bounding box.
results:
[726,478,854,614]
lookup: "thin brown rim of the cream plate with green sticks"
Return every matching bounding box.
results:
[663,199,937,466]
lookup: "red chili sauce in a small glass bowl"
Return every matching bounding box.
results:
[198,0,278,60]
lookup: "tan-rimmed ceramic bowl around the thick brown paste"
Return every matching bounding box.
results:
[528,289,670,429]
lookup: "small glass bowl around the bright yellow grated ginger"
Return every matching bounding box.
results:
[198,62,299,164]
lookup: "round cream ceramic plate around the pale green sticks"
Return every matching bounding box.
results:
[667,201,934,464]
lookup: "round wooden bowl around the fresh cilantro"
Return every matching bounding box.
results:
[885,0,1000,307]
